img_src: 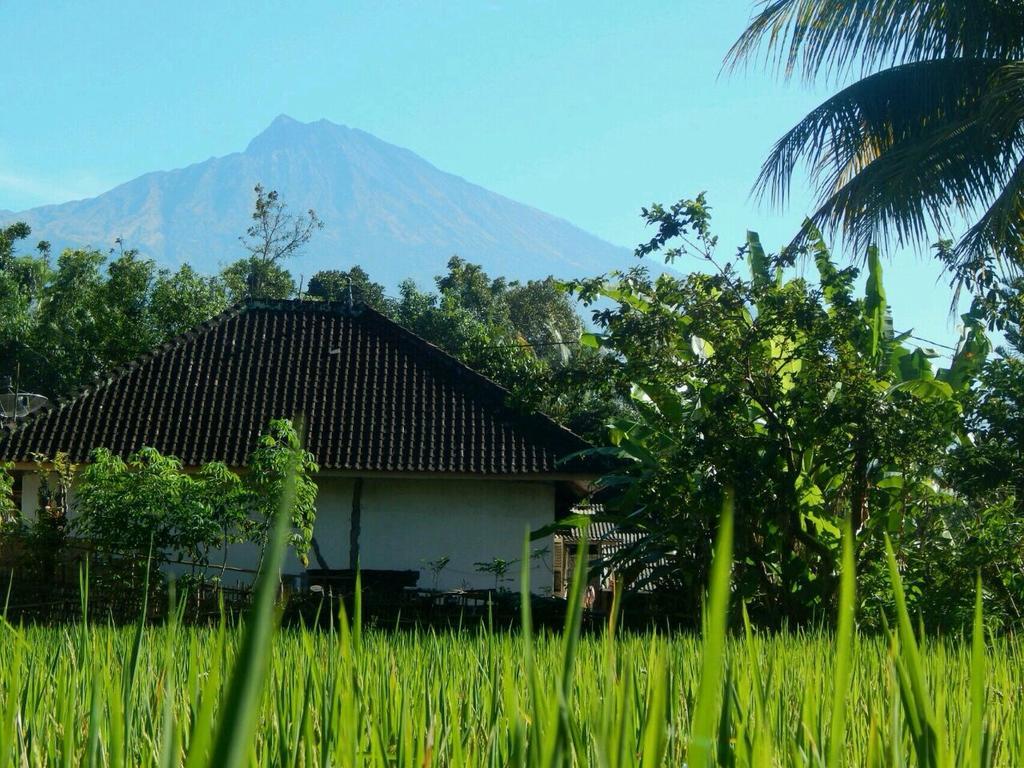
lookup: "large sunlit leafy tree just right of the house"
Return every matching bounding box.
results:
[570,198,987,621]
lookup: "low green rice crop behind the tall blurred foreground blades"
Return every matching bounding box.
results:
[0,628,1024,768]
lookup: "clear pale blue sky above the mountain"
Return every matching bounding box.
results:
[0,0,956,350]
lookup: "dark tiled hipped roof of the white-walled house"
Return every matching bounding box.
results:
[0,301,587,474]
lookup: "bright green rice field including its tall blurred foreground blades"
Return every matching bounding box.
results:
[0,505,1024,768]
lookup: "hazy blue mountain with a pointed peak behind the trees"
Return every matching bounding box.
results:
[0,115,632,286]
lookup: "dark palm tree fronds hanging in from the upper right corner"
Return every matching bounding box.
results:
[726,0,1024,274]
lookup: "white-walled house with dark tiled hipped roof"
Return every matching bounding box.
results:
[0,301,595,592]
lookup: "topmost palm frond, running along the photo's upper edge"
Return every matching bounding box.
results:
[725,0,1024,78]
